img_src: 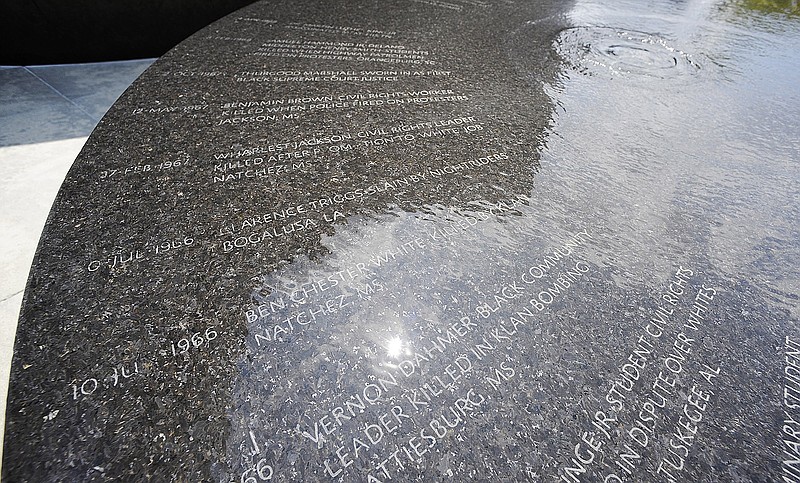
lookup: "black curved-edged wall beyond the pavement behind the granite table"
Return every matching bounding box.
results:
[0,0,253,65]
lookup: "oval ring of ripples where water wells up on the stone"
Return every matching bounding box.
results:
[555,27,700,79]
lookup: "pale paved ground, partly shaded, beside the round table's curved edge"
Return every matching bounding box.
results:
[0,59,154,461]
